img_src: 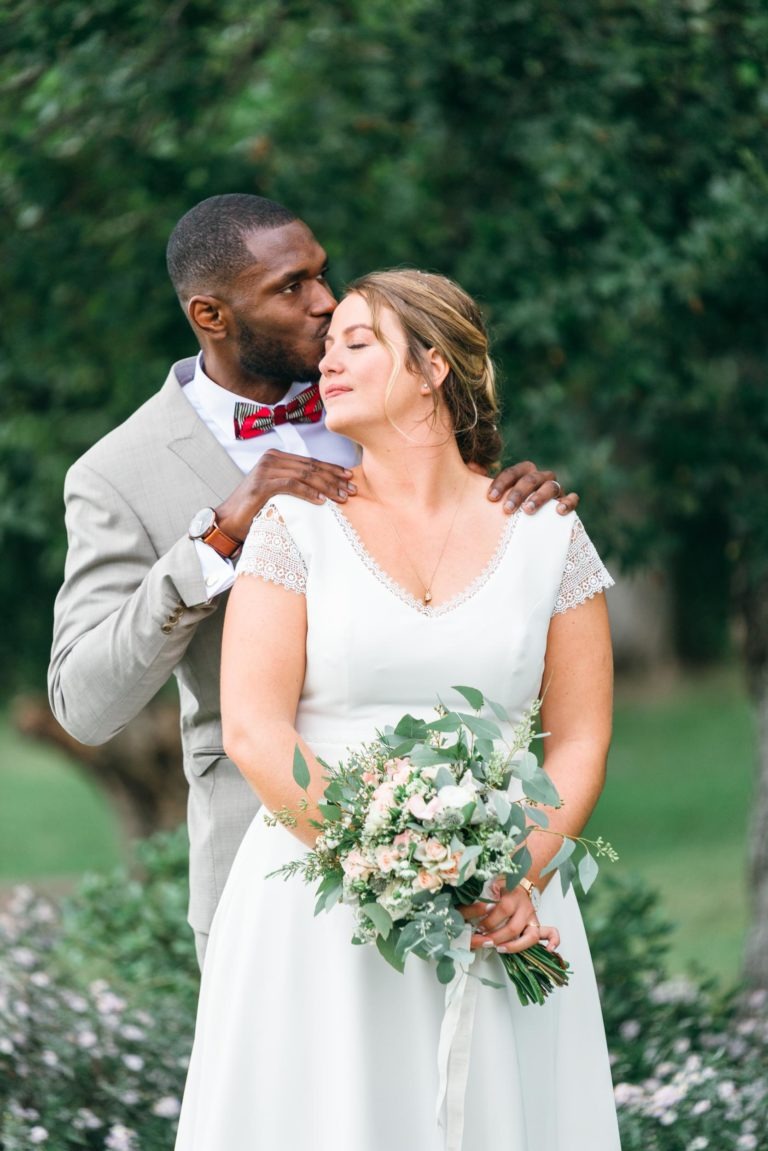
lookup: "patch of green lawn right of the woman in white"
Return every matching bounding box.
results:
[591,672,755,978]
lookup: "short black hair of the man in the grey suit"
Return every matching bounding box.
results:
[166,192,297,306]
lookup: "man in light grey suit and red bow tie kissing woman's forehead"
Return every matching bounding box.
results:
[48,195,578,961]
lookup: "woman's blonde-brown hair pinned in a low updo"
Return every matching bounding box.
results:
[347,268,502,470]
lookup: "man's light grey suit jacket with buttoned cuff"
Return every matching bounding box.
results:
[48,358,258,931]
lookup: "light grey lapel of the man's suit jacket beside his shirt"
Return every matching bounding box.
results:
[160,359,243,501]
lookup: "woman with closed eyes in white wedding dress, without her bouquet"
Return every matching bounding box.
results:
[176,270,619,1151]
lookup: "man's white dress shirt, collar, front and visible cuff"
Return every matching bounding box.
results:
[184,353,360,599]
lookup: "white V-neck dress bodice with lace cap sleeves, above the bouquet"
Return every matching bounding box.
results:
[238,496,611,757]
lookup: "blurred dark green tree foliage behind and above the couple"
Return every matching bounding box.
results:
[0,0,768,980]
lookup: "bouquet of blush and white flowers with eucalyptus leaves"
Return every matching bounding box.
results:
[269,687,616,1004]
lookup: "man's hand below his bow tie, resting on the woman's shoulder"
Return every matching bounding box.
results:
[215,449,356,540]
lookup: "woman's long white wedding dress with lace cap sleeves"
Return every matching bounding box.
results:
[176,496,619,1151]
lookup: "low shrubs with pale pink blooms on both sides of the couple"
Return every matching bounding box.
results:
[0,831,768,1151]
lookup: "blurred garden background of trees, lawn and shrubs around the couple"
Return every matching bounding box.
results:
[0,0,768,1151]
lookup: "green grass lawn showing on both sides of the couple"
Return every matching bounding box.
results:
[0,672,754,978]
